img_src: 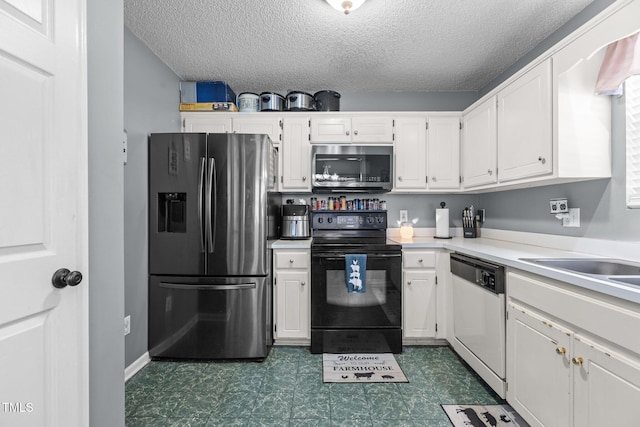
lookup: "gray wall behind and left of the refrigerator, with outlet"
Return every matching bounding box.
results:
[124,28,180,366]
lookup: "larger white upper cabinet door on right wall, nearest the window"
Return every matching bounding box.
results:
[498,59,553,182]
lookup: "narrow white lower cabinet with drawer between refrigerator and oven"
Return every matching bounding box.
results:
[273,249,311,345]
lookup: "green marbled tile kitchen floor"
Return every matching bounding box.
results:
[126,347,504,427]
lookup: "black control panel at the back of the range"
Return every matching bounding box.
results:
[311,211,387,230]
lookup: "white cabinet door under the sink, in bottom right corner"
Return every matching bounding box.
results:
[572,335,640,427]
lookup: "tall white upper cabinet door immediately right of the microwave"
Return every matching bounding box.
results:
[394,117,427,190]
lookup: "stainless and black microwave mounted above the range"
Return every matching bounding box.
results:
[311,144,393,193]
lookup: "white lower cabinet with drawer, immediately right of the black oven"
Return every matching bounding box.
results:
[402,249,437,344]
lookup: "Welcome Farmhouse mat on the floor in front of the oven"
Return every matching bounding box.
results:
[322,353,409,383]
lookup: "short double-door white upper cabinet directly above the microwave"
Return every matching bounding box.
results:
[311,114,393,144]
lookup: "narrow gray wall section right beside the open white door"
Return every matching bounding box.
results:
[89,0,124,427]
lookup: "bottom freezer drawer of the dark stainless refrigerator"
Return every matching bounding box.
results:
[149,276,273,359]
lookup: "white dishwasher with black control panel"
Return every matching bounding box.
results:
[451,253,506,398]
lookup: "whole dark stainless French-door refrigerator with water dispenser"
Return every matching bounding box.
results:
[149,133,280,359]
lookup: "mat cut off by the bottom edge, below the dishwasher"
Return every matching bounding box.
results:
[441,405,529,427]
